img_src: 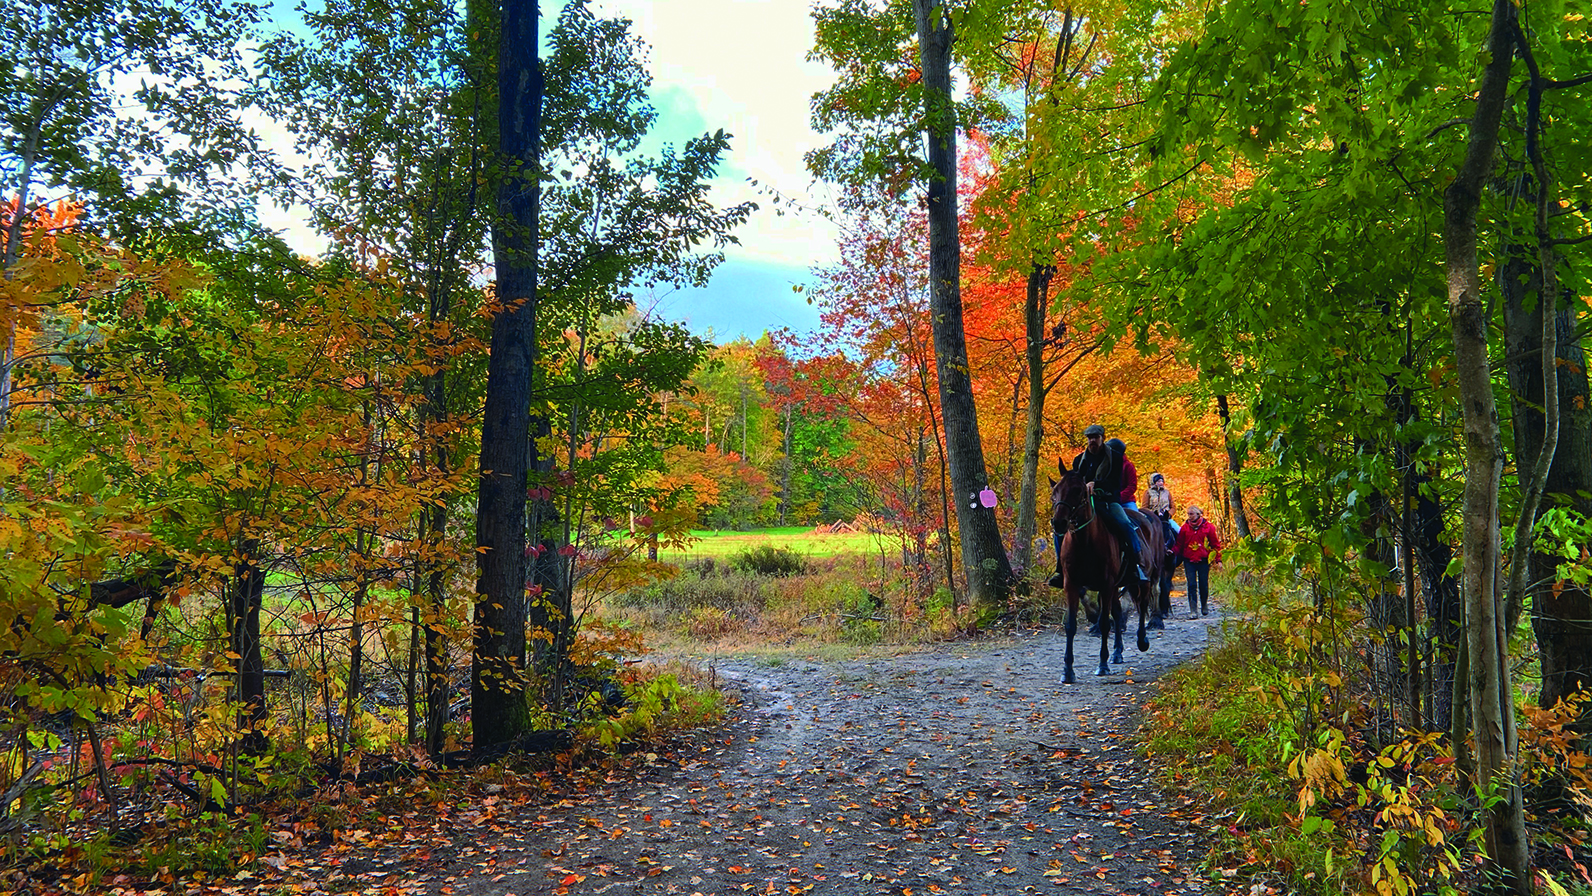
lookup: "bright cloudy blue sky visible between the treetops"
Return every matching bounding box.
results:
[258,0,836,342]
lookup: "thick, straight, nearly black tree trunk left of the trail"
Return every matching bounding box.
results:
[470,0,543,751]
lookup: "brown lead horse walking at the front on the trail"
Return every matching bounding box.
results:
[1051,469,1156,684]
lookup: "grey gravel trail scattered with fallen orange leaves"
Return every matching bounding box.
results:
[428,601,1219,896]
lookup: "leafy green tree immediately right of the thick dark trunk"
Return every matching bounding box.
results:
[529,0,755,707]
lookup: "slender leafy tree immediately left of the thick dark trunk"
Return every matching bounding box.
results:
[258,0,494,758]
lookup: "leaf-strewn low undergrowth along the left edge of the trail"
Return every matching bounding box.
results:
[0,622,724,893]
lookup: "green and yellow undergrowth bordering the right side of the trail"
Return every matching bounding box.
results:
[1143,557,1592,896]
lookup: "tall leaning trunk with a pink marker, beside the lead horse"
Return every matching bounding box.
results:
[912,0,1013,617]
